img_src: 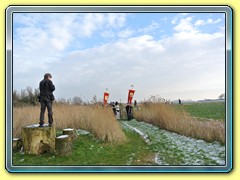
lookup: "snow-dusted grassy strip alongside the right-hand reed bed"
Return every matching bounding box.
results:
[122,120,225,166]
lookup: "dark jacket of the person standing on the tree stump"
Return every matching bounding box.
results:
[39,79,55,99]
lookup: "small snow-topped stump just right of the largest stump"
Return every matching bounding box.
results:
[55,135,72,156]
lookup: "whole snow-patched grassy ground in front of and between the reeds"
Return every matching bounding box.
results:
[13,120,225,166]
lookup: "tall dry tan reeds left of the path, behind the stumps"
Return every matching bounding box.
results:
[13,105,125,142]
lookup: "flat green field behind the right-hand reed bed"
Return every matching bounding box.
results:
[176,103,225,120]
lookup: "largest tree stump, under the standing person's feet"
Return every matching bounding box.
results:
[22,124,56,154]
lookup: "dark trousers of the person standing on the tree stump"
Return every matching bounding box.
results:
[39,99,53,125]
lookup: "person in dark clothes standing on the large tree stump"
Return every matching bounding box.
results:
[39,73,55,127]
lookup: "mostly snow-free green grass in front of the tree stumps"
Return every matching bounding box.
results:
[13,131,154,166]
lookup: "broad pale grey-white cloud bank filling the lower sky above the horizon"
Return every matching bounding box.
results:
[16,29,225,101]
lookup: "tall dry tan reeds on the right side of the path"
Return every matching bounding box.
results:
[134,103,225,144]
